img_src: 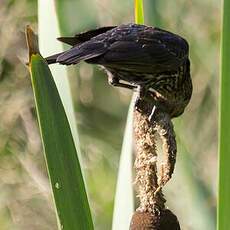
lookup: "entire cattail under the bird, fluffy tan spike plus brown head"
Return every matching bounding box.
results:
[130,98,180,230]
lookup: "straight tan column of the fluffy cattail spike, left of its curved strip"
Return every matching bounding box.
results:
[134,110,165,213]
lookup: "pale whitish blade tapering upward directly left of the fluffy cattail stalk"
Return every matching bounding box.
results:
[112,96,135,230]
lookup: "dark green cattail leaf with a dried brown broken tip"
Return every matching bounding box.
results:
[27,27,93,230]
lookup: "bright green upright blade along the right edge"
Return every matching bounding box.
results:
[217,0,230,230]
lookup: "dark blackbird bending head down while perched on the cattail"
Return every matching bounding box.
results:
[46,24,192,117]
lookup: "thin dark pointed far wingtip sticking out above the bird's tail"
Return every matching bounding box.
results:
[57,26,116,46]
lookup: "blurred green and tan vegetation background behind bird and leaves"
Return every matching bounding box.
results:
[0,0,220,230]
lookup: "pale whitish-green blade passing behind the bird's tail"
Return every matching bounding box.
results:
[38,0,81,158]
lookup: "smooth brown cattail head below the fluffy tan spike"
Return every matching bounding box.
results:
[130,209,180,230]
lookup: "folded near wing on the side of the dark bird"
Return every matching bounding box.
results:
[91,30,188,73]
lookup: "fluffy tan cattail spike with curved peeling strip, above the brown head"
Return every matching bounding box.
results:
[134,95,177,212]
